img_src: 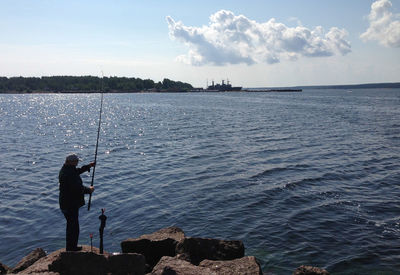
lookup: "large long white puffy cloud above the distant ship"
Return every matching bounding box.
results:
[166,10,351,66]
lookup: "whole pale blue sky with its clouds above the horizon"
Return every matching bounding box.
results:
[0,0,400,87]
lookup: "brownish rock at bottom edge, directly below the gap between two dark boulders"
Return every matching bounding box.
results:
[151,256,217,275]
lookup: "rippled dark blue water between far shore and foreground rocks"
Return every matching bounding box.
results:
[0,89,400,274]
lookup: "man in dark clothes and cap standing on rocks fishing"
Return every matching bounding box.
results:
[58,154,96,251]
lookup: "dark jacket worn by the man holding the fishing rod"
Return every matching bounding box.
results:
[58,164,90,210]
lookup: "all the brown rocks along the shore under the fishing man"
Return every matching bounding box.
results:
[0,227,329,275]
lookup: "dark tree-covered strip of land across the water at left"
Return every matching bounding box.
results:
[0,76,193,93]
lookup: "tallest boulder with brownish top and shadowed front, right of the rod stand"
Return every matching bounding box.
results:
[121,227,185,271]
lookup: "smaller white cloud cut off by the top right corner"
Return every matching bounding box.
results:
[360,0,400,47]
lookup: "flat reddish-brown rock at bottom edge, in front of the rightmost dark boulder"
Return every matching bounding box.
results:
[199,256,263,275]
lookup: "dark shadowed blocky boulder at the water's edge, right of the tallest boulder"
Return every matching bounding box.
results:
[176,238,244,265]
